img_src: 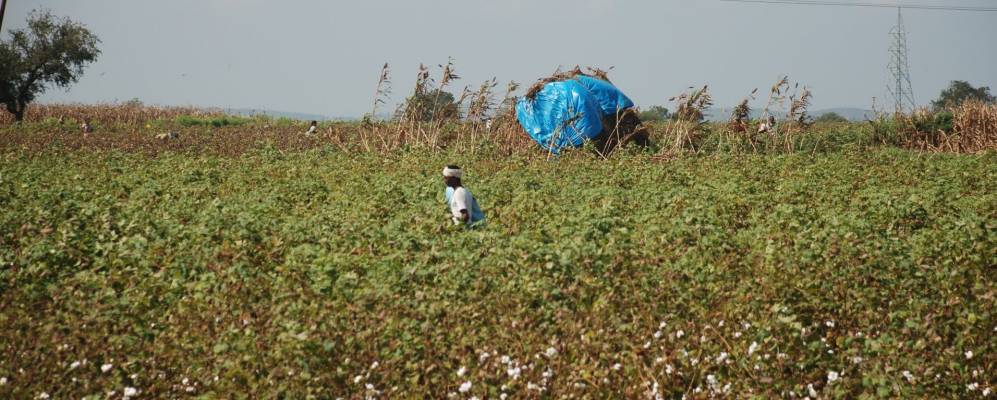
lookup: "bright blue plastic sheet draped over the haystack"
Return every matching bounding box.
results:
[516,75,634,153]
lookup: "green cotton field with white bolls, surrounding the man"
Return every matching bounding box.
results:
[0,147,997,398]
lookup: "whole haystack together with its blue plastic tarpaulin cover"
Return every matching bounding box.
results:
[516,67,648,153]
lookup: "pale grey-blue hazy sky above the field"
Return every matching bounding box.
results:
[4,0,997,116]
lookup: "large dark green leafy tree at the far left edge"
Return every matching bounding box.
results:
[0,10,100,121]
